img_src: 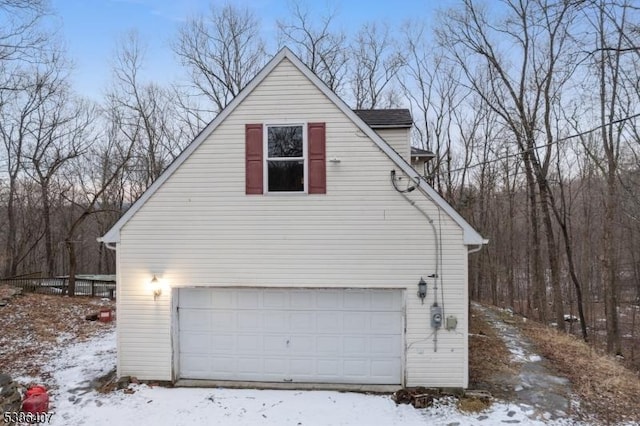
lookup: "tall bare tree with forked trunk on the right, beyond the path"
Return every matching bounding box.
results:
[438,0,577,328]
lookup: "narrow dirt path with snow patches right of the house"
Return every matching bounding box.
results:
[474,303,577,421]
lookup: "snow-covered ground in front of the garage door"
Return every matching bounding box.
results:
[25,330,592,426]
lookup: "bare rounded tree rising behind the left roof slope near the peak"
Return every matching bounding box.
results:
[173,3,266,121]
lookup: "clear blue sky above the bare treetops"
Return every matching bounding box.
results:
[51,0,454,98]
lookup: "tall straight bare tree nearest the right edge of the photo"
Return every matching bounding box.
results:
[582,0,638,354]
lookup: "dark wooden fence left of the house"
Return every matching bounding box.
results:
[0,278,116,300]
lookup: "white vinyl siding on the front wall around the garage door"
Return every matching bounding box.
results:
[117,59,467,387]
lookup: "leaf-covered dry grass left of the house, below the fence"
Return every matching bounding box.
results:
[0,287,115,377]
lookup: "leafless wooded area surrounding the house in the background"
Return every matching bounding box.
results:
[0,0,640,368]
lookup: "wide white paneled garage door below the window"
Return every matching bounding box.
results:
[178,288,403,384]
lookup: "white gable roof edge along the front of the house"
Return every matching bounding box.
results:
[98,47,488,245]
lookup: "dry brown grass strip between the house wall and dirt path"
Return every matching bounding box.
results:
[469,307,515,398]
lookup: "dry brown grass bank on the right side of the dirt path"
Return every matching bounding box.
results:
[518,321,640,424]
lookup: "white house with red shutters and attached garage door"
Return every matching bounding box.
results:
[99,48,486,389]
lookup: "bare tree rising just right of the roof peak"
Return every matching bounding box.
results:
[278,0,348,94]
